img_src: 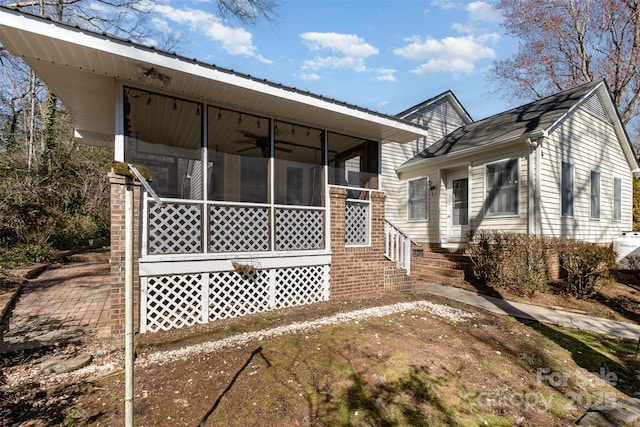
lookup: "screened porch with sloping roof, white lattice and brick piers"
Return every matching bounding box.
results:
[0,8,427,334]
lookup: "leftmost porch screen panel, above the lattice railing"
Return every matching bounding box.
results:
[124,87,204,199]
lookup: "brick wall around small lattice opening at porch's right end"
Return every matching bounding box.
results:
[329,187,388,298]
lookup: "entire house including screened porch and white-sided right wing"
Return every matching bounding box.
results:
[0,7,637,334]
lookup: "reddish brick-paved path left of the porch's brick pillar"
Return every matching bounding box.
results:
[0,262,111,353]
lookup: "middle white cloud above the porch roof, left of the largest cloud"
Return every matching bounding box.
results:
[300,32,379,72]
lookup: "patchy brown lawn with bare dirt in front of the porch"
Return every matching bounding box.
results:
[0,293,640,426]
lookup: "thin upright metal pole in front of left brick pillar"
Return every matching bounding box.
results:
[124,178,134,427]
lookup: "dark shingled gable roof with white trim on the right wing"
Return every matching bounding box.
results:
[397,80,638,173]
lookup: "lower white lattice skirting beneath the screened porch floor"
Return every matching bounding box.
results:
[140,265,330,332]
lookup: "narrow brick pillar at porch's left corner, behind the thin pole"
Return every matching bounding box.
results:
[109,173,140,335]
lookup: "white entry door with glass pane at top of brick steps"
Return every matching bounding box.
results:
[447,172,469,242]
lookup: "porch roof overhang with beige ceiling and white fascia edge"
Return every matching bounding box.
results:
[0,7,426,146]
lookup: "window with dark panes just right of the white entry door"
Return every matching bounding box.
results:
[485,158,520,216]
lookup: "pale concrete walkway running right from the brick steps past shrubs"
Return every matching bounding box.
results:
[425,284,640,340]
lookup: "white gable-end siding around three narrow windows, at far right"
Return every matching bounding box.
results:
[538,97,632,244]
